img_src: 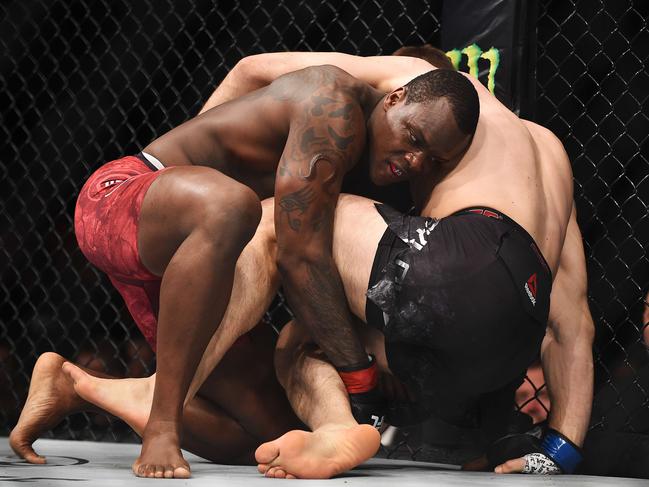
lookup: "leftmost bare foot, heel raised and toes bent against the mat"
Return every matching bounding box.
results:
[9,352,89,463]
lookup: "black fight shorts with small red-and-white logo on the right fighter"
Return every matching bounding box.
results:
[366,205,552,426]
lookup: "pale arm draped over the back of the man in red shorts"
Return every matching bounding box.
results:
[200,52,435,113]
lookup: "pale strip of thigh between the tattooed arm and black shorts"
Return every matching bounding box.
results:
[333,194,387,320]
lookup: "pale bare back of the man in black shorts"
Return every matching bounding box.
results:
[426,103,572,271]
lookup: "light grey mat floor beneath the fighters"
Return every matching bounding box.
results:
[0,438,649,487]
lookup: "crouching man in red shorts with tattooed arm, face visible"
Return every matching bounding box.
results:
[8,58,478,477]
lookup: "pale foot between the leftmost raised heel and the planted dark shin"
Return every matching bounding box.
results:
[63,362,155,436]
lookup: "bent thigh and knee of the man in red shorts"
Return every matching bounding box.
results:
[138,166,261,275]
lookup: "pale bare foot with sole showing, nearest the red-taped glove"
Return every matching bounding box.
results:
[255,424,381,479]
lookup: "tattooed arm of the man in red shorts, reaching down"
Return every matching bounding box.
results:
[275,67,367,367]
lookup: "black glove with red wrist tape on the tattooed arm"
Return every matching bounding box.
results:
[337,355,386,429]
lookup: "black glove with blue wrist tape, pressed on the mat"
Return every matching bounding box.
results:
[487,427,582,474]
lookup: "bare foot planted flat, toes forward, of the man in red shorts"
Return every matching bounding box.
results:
[133,420,191,479]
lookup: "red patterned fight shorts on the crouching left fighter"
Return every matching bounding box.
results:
[74,156,165,351]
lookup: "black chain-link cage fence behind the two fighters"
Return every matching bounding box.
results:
[0,0,649,461]
